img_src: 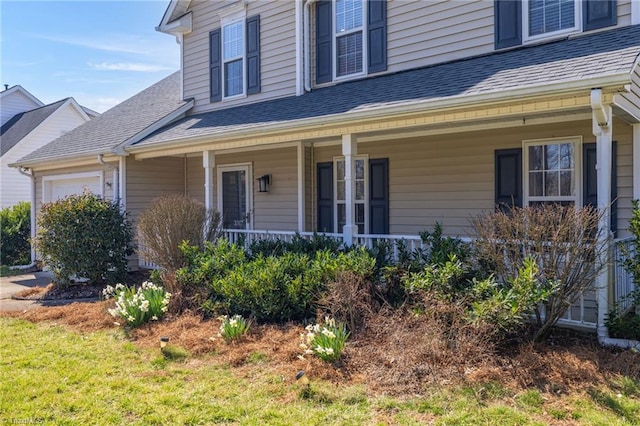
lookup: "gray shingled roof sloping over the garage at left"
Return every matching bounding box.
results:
[17,72,188,164]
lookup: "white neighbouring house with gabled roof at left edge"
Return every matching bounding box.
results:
[0,85,98,208]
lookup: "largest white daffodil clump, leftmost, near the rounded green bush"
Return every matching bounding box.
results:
[102,281,171,327]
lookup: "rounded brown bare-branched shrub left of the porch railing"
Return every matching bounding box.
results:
[138,194,221,271]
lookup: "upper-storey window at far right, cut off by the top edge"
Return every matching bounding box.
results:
[522,0,582,40]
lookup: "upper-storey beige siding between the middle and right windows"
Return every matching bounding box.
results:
[387,0,494,72]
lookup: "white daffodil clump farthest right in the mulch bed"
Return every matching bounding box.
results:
[300,317,349,362]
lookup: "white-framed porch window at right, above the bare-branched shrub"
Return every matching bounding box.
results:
[524,139,580,205]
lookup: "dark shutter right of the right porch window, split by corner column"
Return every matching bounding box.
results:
[582,141,618,237]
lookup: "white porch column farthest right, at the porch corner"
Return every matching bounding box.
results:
[591,89,613,341]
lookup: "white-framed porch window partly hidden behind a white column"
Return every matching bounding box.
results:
[333,156,369,234]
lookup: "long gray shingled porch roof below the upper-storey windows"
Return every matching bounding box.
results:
[135,25,640,146]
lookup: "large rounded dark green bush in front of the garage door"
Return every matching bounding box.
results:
[36,194,133,285]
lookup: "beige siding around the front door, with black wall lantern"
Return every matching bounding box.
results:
[214,147,298,231]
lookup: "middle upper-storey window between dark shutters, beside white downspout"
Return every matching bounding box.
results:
[333,0,366,78]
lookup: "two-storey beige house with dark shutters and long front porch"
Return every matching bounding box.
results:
[10,0,640,338]
